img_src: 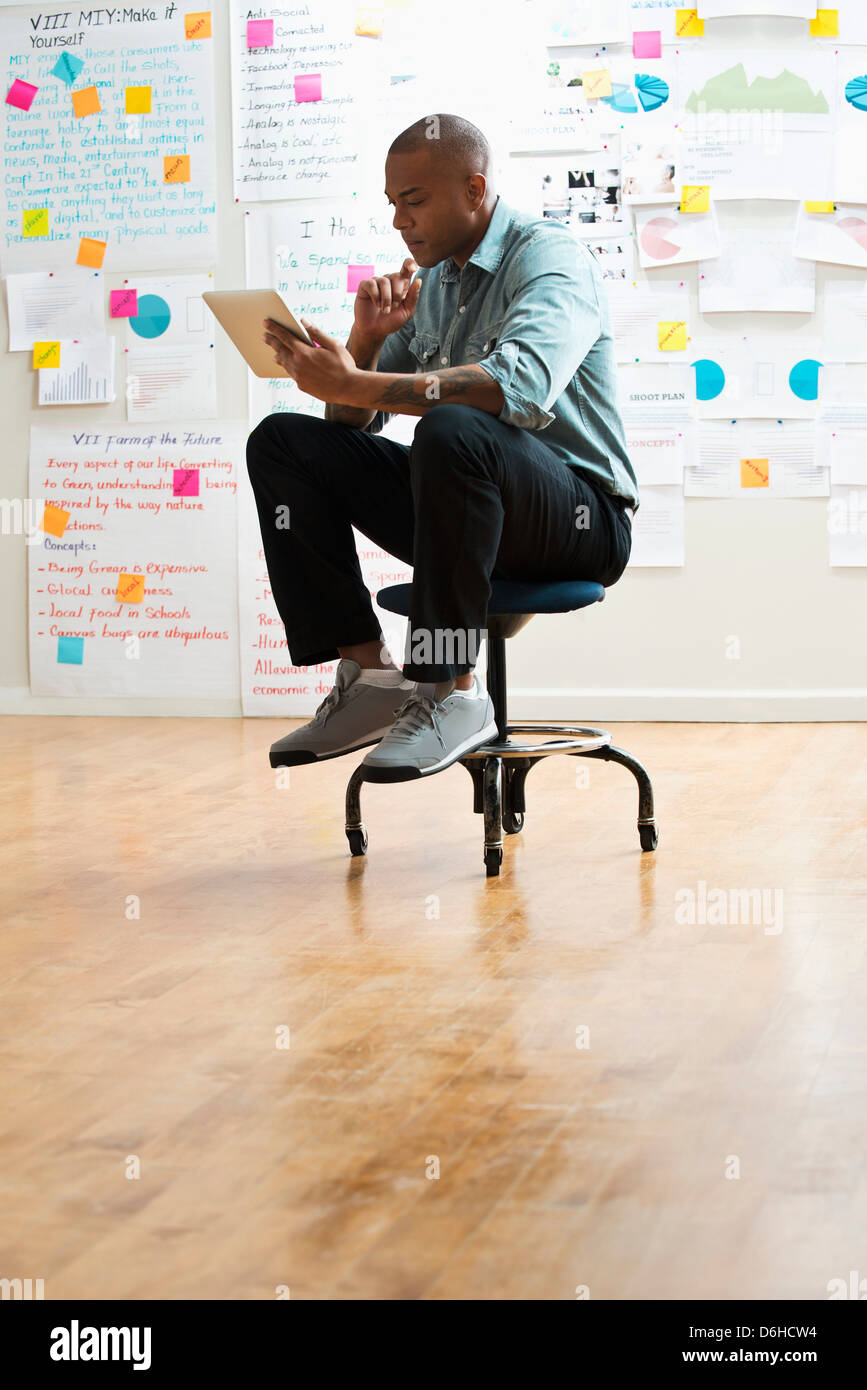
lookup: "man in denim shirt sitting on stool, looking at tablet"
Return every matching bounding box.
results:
[247,115,639,781]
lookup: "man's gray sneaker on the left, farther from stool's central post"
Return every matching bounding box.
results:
[270,656,415,767]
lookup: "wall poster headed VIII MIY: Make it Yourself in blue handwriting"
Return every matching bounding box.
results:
[0,6,217,274]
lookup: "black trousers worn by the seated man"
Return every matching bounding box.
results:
[247,403,632,681]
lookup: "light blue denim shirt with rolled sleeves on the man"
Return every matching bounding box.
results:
[367,197,639,510]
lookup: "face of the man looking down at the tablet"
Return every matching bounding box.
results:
[385,152,484,265]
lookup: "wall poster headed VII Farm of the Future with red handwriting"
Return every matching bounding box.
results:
[28,421,246,699]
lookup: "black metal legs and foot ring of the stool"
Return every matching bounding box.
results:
[346,724,659,878]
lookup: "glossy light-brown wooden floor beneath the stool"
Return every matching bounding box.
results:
[0,712,867,1300]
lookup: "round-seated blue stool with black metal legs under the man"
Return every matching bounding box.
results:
[346,580,659,878]
